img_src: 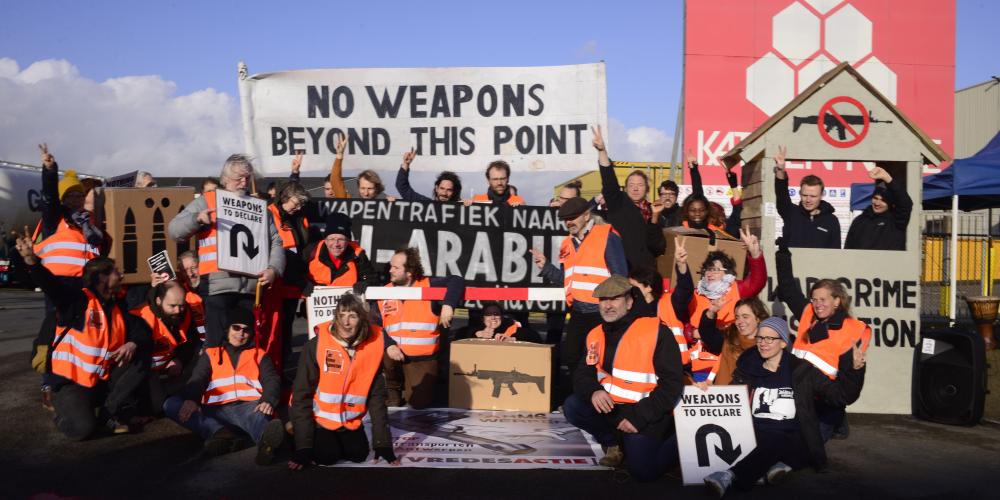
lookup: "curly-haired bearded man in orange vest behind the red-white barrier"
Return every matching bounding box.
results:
[375,247,465,410]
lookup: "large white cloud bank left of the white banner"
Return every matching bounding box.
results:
[0,58,243,177]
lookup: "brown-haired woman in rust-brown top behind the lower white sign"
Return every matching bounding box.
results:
[698,296,771,385]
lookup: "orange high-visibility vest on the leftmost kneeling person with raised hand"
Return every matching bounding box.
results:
[52,288,125,387]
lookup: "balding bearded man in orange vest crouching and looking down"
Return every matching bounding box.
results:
[131,281,201,415]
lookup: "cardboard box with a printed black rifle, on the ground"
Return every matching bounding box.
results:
[448,339,552,413]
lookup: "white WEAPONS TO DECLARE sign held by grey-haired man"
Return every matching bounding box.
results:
[215,189,271,276]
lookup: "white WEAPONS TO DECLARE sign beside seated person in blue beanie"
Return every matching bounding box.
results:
[674,385,757,484]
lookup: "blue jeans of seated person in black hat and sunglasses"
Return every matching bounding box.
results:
[163,396,271,443]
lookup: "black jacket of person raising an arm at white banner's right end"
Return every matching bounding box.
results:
[598,162,667,269]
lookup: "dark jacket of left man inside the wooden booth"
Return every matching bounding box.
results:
[774,177,840,248]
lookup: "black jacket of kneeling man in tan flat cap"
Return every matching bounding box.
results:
[573,310,684,439]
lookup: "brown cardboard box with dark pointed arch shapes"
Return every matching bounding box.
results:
[104,187,195,284]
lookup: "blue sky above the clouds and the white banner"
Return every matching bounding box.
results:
[0,0,1000,201]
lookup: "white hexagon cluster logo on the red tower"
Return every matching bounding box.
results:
[746,0,896,115]
